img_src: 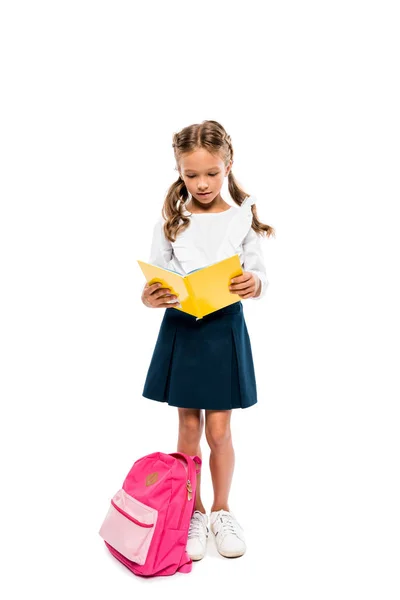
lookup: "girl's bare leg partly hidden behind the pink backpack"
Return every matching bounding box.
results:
[177,408,206,513]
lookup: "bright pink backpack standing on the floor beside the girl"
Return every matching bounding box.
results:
[99,452,202,576]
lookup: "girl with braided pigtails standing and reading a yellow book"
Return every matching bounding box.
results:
[142,121,275,560]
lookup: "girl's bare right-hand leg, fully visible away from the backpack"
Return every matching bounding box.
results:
[206,410,235,511]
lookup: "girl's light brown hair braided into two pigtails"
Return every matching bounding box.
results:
[162,121,275,242]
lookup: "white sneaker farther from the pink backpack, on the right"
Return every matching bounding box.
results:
[210,509,246,558]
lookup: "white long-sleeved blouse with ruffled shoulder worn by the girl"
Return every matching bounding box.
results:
[148,196,269,300]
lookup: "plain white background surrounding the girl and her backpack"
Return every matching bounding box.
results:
[0,0,400,600]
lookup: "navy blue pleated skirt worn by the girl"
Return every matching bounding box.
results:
[142,301,257,410]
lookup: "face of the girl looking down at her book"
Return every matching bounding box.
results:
[179,148,232,204]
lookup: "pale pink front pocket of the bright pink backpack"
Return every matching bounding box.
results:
[99,489,158,565]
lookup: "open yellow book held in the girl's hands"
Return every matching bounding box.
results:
[137,254,243,319]
